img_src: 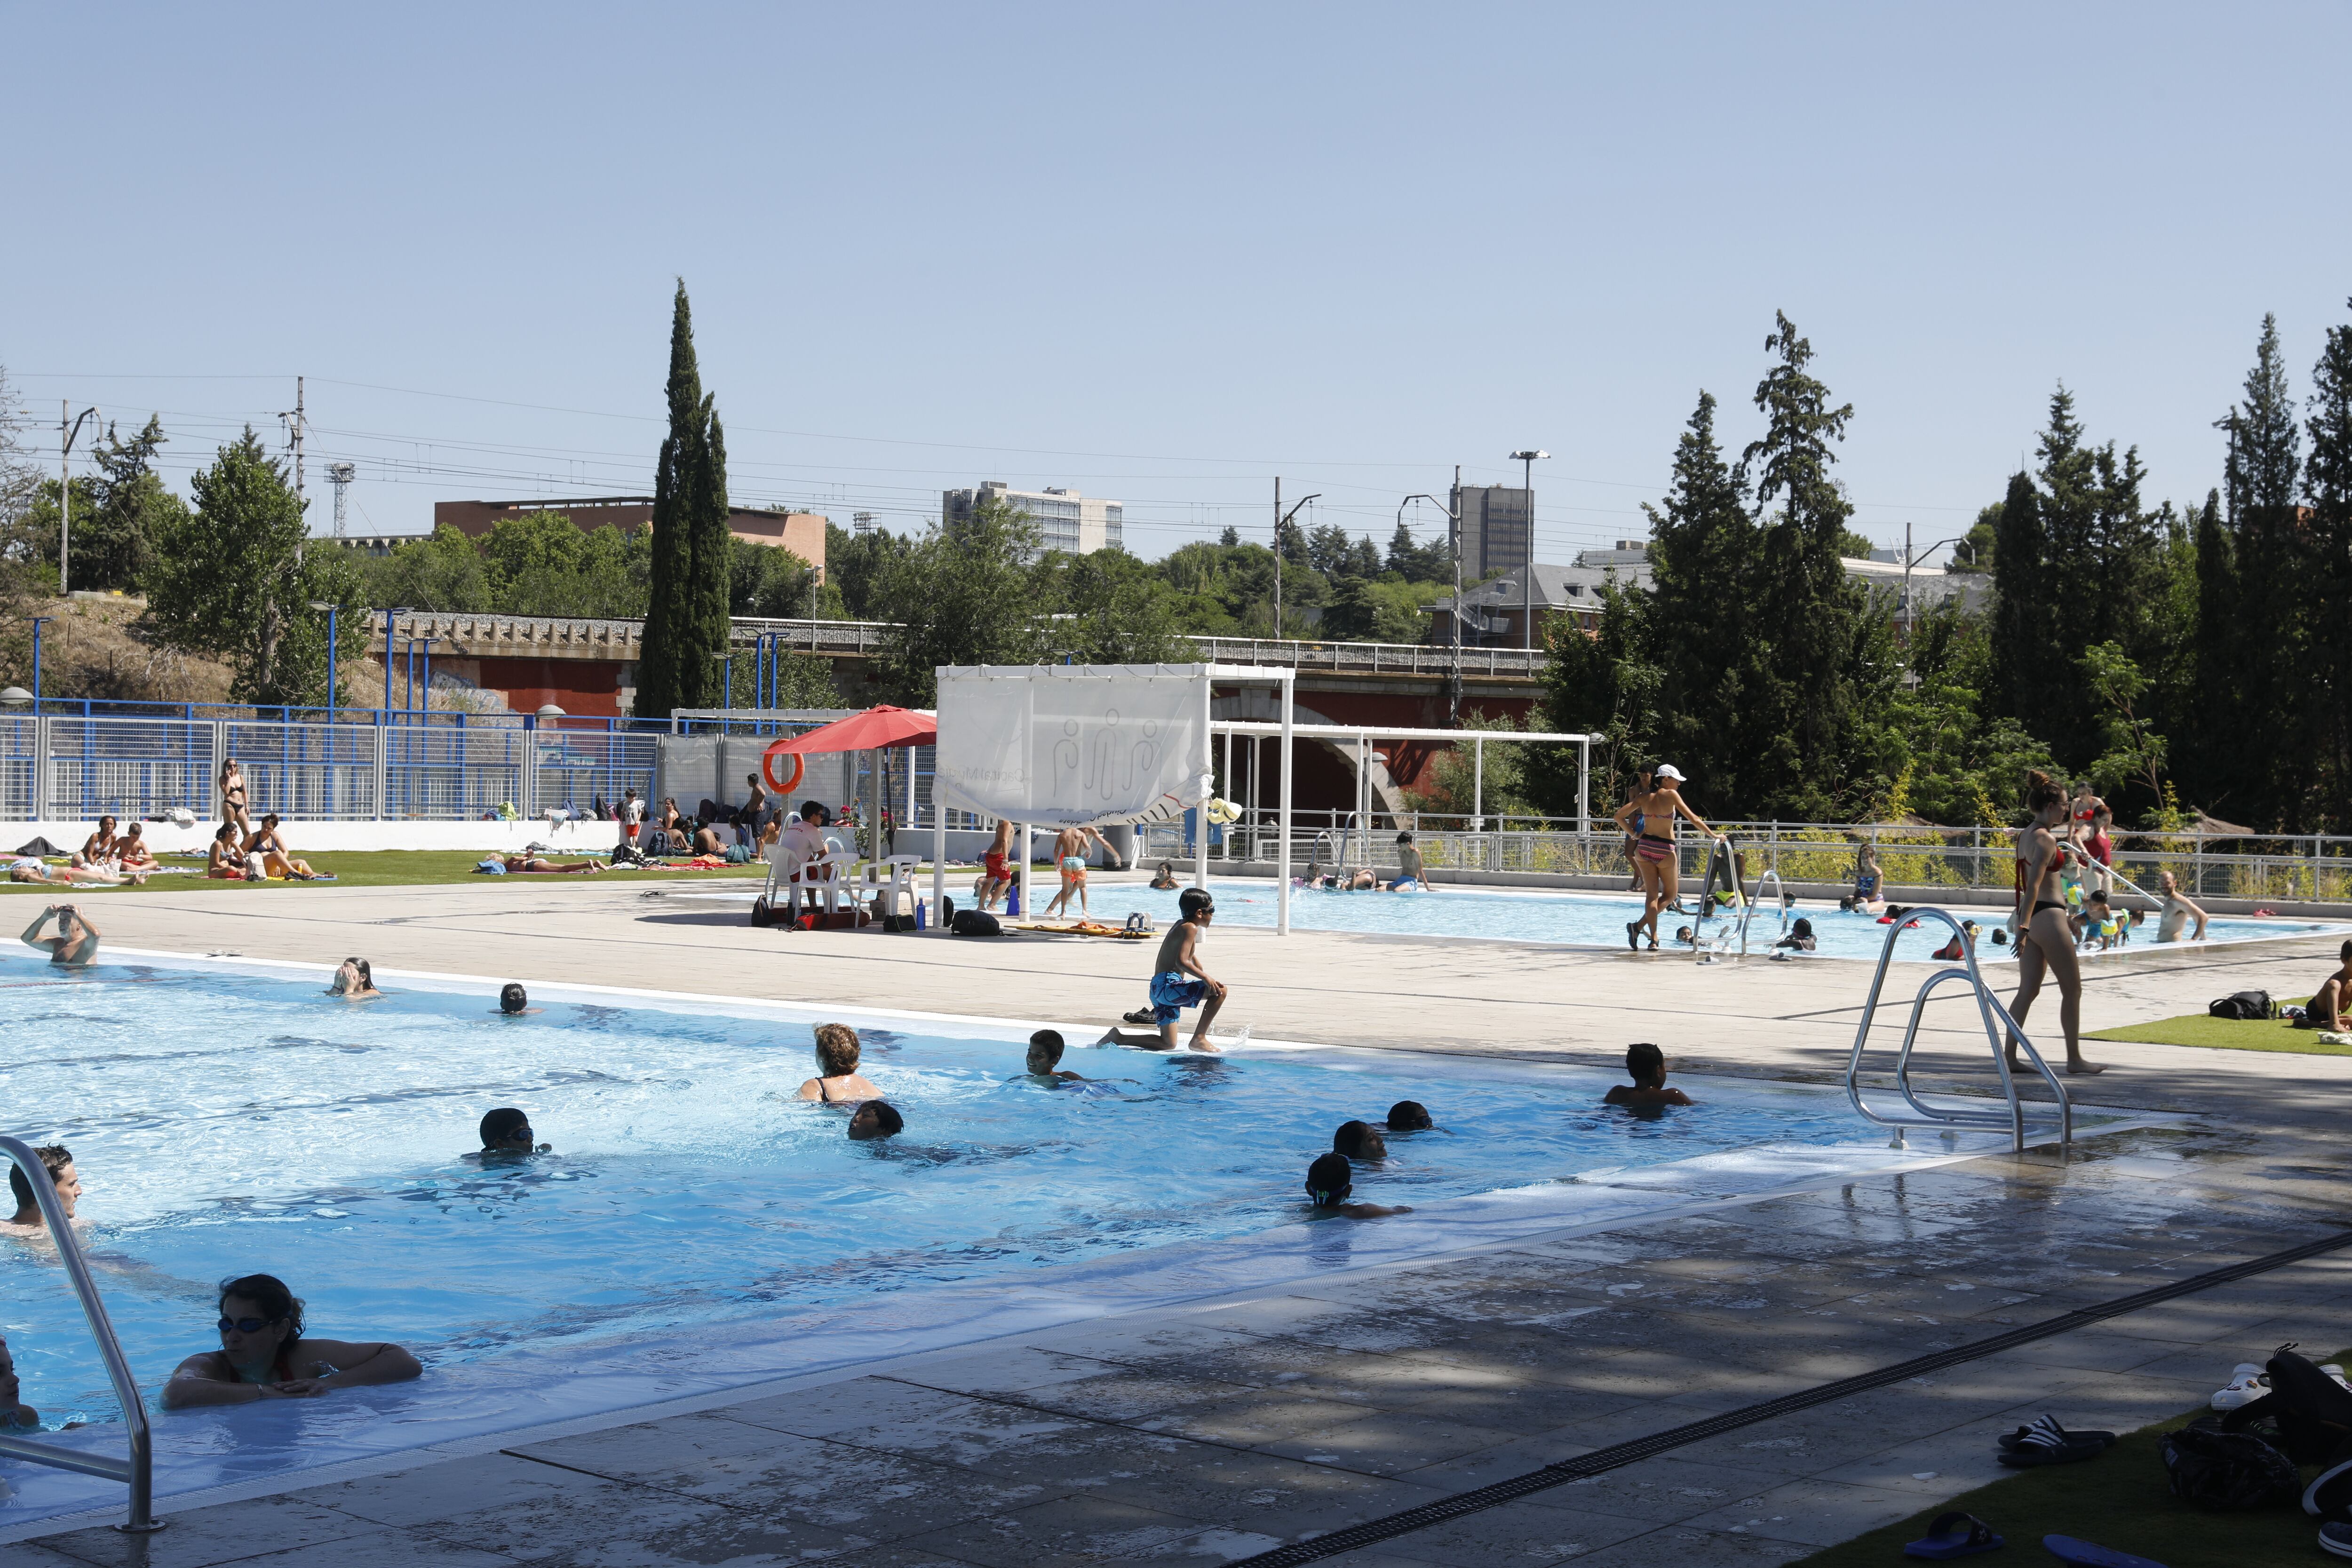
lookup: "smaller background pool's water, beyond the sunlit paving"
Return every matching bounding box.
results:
[969,872,2352,962]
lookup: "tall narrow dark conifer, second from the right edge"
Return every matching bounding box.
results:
[2206,315,2305,828]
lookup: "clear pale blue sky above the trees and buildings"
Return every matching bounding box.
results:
[0,0,2352,559]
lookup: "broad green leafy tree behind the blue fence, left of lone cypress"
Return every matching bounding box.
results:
[143,425,367,705]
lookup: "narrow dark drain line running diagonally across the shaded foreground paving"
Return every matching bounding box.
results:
[1228,1232,2352,1568]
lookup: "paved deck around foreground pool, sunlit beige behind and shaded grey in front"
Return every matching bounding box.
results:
[18,882,2352,1568]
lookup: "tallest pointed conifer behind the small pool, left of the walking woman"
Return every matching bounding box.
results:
[1740,315,1867,820]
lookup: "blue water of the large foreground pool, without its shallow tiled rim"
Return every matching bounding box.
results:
[0,964,1863,1410]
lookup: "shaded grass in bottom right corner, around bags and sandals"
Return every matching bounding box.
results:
[1797,1352,2352,1568]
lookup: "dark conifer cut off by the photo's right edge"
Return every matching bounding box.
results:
[2298,301,2352,832]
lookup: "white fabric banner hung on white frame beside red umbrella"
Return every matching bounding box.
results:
[931,665,1211,828]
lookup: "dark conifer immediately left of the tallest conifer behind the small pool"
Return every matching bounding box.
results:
[1642,392,1769,802]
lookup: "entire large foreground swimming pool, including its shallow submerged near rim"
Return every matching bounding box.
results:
[0,962,2154,1530]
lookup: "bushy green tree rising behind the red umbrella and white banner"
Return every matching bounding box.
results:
[875,498,1049,708]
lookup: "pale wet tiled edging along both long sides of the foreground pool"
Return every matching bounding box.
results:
[0,952,2180,1540]
